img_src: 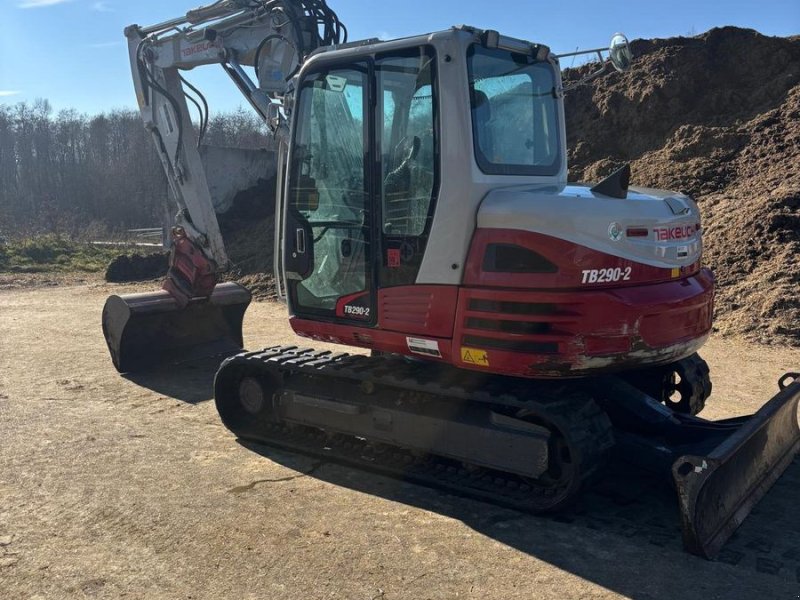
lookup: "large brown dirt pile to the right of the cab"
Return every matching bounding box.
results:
[565,27,800,345]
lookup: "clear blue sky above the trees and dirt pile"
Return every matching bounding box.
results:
[0,0,800,113]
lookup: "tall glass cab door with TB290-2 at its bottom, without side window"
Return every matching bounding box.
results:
[284,63,377,325]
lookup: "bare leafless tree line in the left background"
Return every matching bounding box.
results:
[0,100,266,237]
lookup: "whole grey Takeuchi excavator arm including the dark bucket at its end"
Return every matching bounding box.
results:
[103,0,347,372]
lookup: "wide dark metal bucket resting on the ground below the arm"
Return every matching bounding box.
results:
[103,283,252,373]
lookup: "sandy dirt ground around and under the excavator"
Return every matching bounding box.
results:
[0,280,800,600]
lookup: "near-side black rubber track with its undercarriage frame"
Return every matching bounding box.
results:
[215,348,614,512]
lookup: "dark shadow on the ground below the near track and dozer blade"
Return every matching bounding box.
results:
[240,441,800,600]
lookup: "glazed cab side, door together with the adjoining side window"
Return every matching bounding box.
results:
[283,47,439,326]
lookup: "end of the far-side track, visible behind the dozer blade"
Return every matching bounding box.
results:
[626,354,711,415]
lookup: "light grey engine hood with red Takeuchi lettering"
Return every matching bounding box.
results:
[477,184,702,268]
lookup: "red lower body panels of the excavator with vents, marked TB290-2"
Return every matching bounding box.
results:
[291,230,714,378]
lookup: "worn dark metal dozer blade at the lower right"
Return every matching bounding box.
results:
[672,376,800,558]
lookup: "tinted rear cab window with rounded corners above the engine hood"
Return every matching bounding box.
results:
[468,45,561,175]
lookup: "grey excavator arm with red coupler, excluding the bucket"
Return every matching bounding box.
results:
[125,0,346,307]
